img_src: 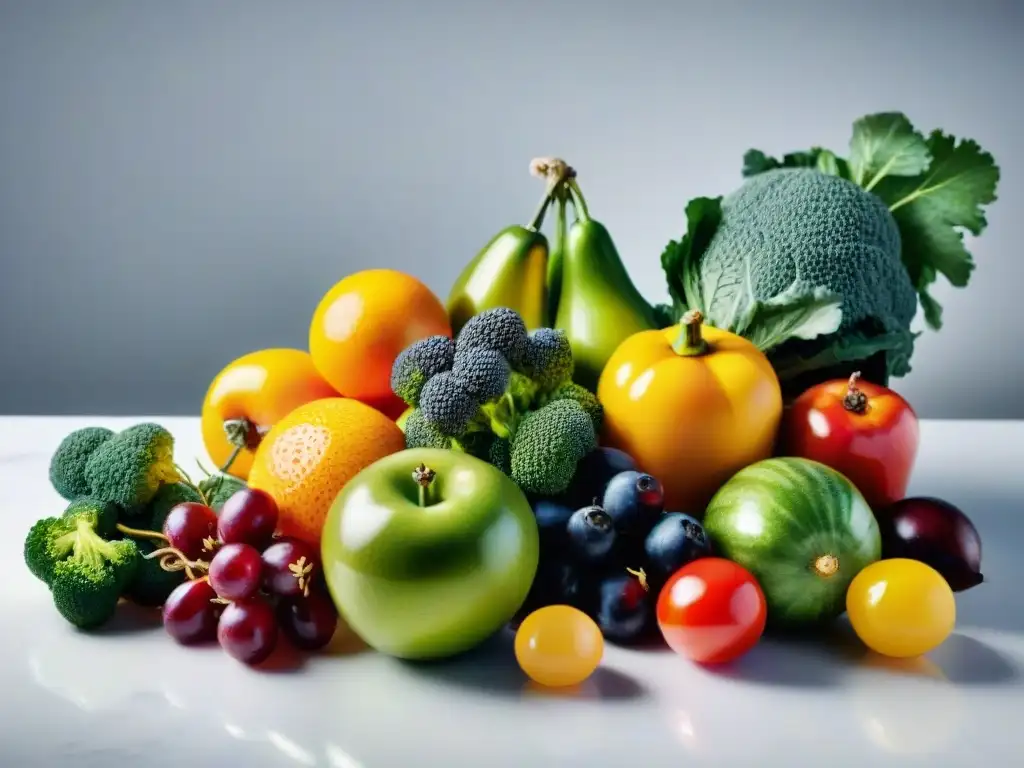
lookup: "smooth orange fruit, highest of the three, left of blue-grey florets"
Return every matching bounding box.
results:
[309,269,452,405]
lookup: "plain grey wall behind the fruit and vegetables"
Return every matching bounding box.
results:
[0,0,1024,418]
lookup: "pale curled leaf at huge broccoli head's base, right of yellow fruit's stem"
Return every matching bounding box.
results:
[733,283,843,352]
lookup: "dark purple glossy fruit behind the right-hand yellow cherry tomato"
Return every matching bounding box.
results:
[874,497,985,592]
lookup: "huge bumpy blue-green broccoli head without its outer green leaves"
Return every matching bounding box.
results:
[698,168,918,389]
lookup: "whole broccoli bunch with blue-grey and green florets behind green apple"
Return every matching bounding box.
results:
[391,307,602,494]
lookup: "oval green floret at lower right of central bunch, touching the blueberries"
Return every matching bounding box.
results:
[510,399,597,496]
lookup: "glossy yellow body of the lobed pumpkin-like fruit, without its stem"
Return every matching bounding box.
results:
[597,315,782,517]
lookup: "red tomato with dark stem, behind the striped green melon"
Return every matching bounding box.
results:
[780,374,919,510]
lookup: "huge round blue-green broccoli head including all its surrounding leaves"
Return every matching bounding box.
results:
[659,113,999,391]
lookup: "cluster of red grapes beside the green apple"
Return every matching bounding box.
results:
[157,488,338,665]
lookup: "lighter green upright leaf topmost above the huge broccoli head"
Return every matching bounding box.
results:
[850,112,931,190]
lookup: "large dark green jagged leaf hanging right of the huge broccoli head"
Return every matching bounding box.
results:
[873,126,999,330]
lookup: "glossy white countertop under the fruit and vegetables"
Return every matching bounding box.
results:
[0,417,1024,768]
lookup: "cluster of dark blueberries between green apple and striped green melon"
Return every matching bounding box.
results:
[513,447,712,644]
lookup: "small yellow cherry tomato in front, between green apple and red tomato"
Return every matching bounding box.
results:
[515,605,604,688]
